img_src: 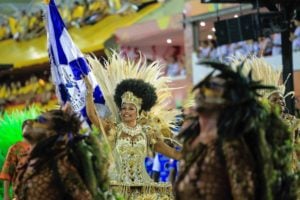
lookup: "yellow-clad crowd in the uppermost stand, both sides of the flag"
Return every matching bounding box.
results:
[0,0,156,41]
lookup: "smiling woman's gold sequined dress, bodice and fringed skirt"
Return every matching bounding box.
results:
[109,123,173,200]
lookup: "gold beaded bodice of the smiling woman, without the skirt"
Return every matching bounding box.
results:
[111,123,153,185]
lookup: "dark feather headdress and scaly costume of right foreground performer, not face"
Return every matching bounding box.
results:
[176,62,297,200]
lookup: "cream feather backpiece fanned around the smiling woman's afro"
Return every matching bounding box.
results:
[87,51,179,138]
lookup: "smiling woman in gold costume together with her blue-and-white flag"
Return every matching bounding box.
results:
[39,0,181,199]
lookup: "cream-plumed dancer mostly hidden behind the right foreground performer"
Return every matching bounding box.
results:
[232,57,300,172]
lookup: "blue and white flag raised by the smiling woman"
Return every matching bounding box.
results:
[45,0,105,122]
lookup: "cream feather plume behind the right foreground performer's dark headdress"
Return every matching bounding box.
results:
[230,56,285,98]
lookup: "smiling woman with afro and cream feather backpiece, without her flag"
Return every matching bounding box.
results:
[85,53,180,199]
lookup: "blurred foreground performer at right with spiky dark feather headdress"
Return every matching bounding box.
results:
[175,62,297,200]
